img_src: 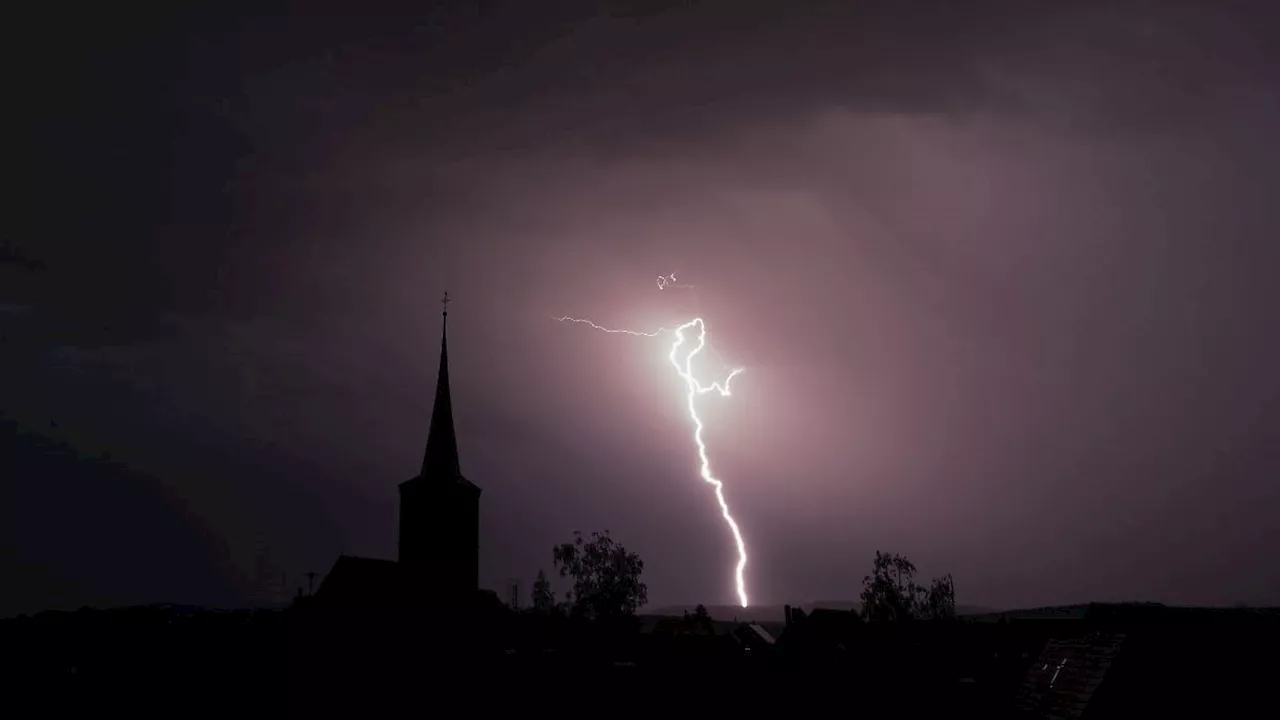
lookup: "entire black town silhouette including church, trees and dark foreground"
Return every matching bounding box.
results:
[0,302,1280,719]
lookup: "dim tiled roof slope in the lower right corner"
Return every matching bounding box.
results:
[1016,635,1124,720]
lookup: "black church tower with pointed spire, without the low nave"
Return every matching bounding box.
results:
[399,293,480,602]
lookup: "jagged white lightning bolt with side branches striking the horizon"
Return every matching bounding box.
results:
[556,298,748,607]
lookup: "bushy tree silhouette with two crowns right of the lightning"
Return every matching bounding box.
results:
[861,551,956,621]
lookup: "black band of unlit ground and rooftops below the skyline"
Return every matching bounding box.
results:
[0,606,1280,719]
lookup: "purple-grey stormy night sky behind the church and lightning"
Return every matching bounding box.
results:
[0,0,1280,615]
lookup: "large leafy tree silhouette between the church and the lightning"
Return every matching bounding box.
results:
[552,530,649,620]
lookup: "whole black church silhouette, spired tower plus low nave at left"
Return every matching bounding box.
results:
[312,293,497,610]
